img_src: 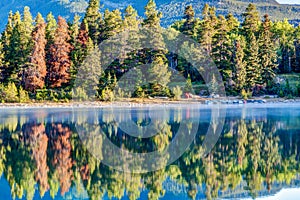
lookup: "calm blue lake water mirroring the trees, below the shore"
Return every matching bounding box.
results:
[0,104,300,199]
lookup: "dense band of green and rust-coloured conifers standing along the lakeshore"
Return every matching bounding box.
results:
[0,0,300,102]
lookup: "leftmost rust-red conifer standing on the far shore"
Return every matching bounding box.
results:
[23,20,47,92]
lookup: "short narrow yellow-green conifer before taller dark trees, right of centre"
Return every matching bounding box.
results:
[233,37,247,92]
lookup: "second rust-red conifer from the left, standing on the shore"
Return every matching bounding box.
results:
[47,16,71,88]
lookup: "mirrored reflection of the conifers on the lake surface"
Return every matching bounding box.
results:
[0,105,300,199]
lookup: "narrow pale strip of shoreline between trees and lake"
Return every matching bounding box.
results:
[0,98,300,109]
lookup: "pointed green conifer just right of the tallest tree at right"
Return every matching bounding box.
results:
[259,15,277,86]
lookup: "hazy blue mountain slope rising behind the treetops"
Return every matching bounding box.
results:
[0,0,300,30]
